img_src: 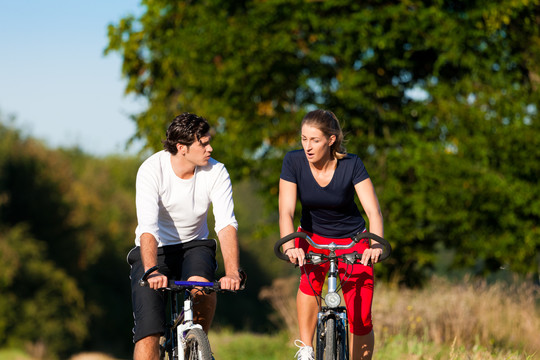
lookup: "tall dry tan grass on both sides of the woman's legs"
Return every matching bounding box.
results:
[261,278,540,359]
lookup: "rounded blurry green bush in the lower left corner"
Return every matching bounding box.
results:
[0,226,88,355]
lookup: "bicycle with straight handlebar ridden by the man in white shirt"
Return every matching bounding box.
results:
[139,266,247,360]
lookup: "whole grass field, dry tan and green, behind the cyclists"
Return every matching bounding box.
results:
[0,278,540,360]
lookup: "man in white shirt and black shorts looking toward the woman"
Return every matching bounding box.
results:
[128,113,240,360]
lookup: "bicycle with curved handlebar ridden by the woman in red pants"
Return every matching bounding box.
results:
[274,232,392,360]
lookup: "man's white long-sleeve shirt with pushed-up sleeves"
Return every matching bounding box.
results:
[135,150,238,246]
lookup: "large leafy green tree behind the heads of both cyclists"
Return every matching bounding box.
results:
[106,0,540,283]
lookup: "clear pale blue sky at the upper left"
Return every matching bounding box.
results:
[0,0,144,156]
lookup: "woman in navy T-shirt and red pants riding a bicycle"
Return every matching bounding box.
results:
[279,110,383,360]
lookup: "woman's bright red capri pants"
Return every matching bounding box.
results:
[295,229,373,335]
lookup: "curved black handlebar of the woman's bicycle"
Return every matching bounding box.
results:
[274,232,392,261]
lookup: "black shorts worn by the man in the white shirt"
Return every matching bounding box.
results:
[127,239,217,343]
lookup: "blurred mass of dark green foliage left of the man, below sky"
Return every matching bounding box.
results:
[0,119,140,357]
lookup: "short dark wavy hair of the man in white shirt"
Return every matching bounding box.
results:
[162,112,210,155]
